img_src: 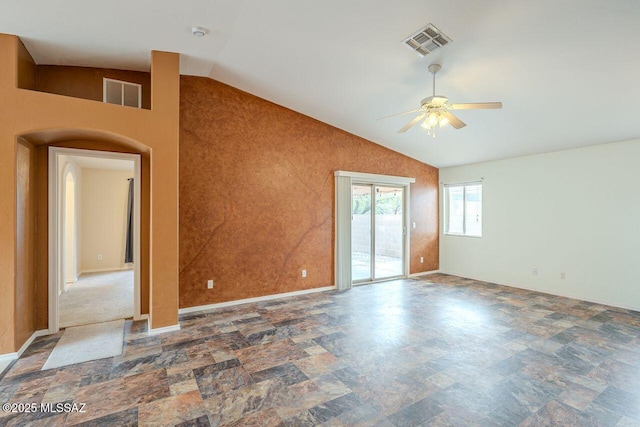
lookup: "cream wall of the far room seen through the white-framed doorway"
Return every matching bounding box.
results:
[80,168,133,272]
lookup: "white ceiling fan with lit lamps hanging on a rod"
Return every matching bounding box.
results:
[379,64,502,138]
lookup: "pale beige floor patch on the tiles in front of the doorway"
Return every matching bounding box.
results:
[42,320,124,371]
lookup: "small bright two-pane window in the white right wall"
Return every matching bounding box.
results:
[444,182,482,237]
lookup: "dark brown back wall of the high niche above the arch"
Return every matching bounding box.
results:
[36,65,151,109]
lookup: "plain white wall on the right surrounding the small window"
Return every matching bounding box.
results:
[440,140,640,310]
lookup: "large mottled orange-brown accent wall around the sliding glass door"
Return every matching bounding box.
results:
[180,76,438,307]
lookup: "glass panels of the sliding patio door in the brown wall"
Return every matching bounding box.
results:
[351,184,405,283]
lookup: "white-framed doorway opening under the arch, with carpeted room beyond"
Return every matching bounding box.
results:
[49,147,142,333]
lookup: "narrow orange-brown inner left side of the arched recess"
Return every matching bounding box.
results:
[14,141,36,348]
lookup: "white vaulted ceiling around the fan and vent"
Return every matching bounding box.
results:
[0,0,640,167]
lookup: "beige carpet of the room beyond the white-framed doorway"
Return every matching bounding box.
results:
[58,270,133,328]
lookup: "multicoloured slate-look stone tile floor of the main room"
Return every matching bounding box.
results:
[0,275,640,426]
